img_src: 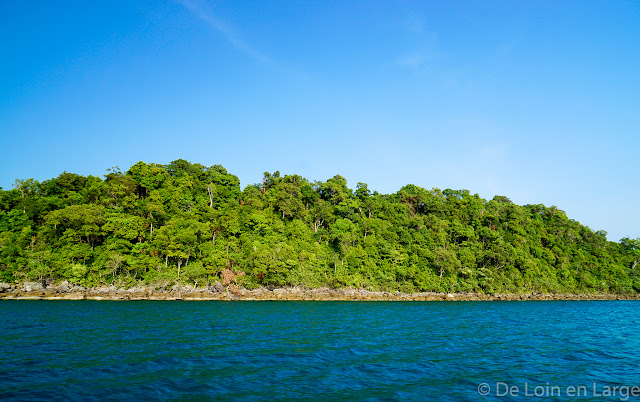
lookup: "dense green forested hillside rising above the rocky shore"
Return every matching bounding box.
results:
[0,160,640,293]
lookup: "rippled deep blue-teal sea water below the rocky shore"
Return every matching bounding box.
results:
[0,300,640,401]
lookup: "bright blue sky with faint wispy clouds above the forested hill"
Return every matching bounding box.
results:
[0,0,640,241]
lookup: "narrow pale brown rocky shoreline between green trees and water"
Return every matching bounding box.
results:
[0,281,640,301]
